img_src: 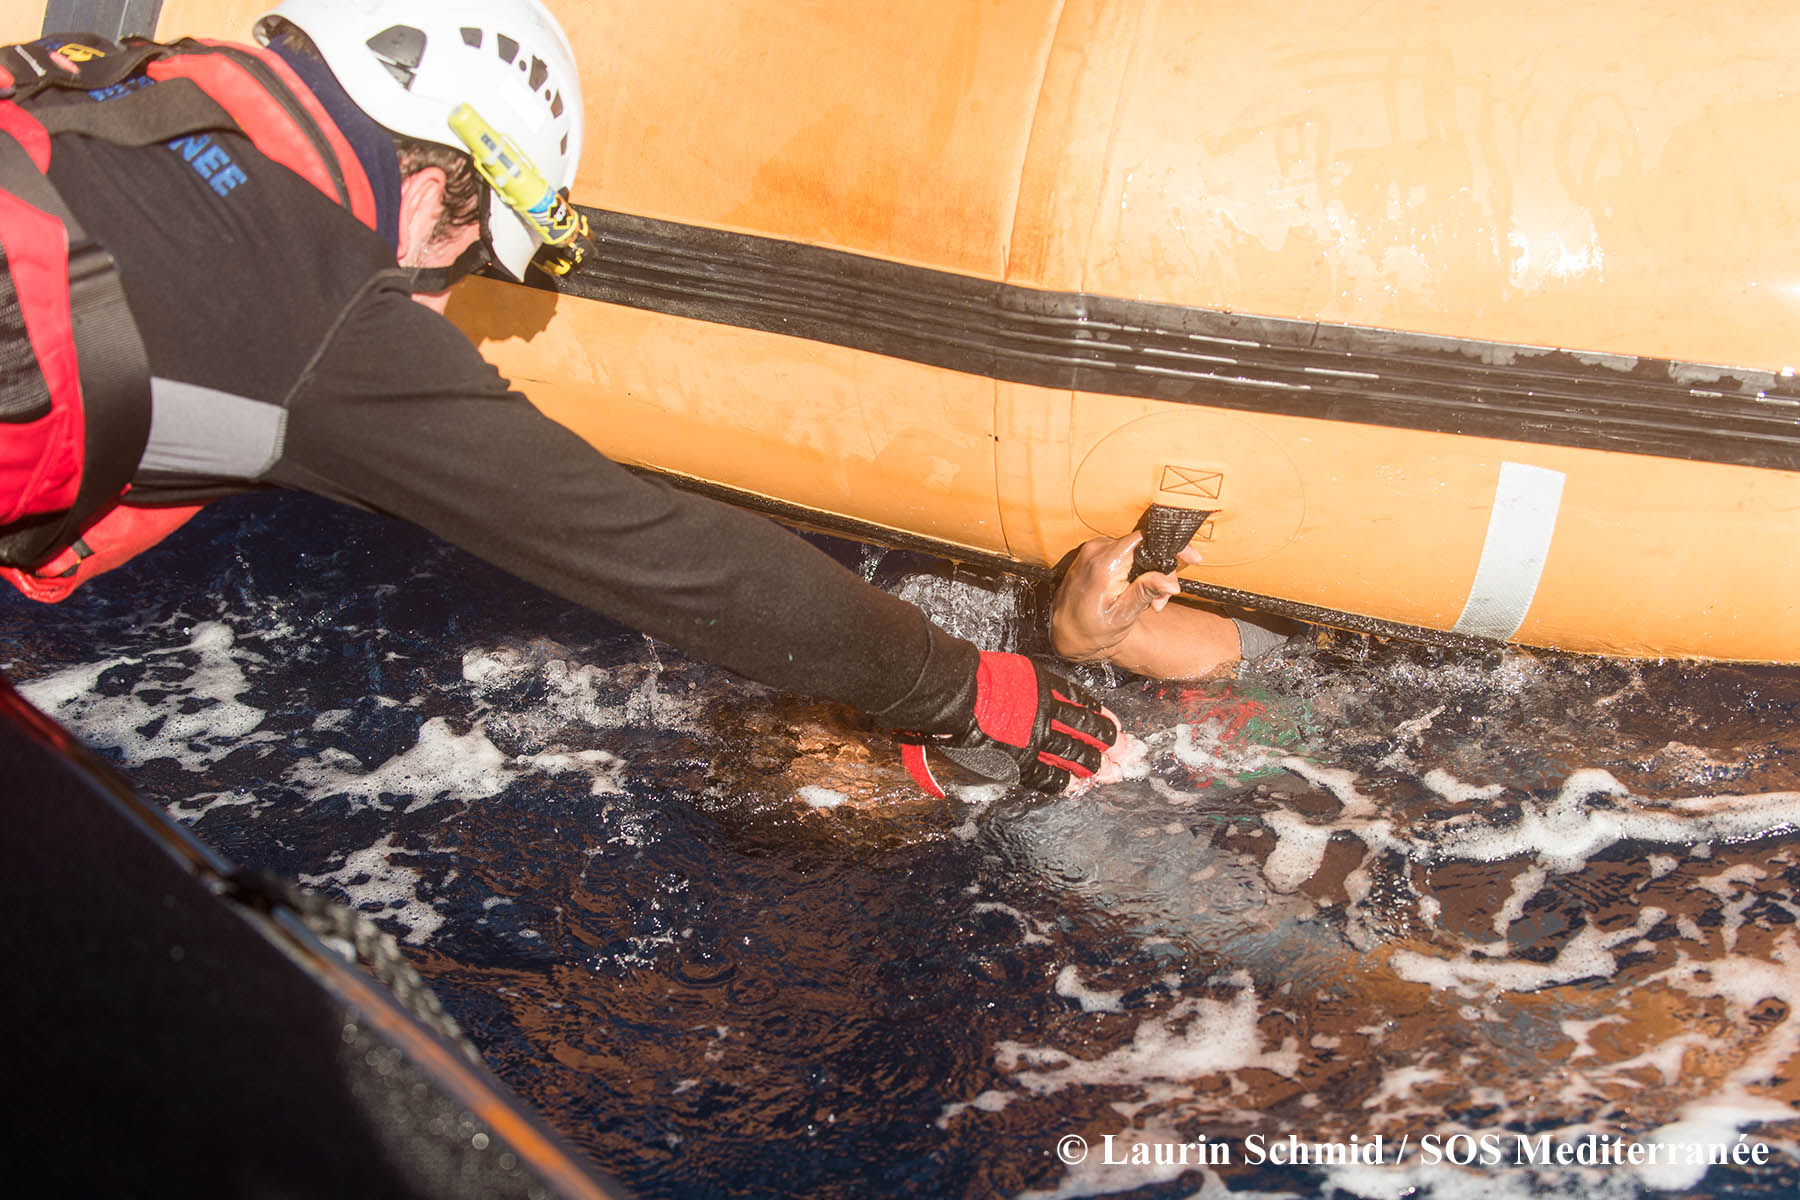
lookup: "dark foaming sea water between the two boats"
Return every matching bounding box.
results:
[0,497,1800,1196]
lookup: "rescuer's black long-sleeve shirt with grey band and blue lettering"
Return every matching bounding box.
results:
[50,103,976,732]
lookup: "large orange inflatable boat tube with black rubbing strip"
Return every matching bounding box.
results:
[28,0,1800,662]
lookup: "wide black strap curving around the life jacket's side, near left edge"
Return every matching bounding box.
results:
[0,133,149,567]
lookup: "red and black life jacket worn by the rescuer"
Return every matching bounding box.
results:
[0,36,376,601]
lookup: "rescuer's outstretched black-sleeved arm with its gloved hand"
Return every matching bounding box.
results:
[268,282,1112,790]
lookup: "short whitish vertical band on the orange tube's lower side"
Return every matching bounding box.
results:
[1451,462,1566,640]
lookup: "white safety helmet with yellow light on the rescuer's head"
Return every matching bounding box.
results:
[256,0,581,279]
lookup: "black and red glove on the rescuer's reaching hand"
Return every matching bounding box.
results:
[896,653,1120,795]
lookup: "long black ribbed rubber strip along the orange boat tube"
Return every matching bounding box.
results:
[531,209,1800,471]
